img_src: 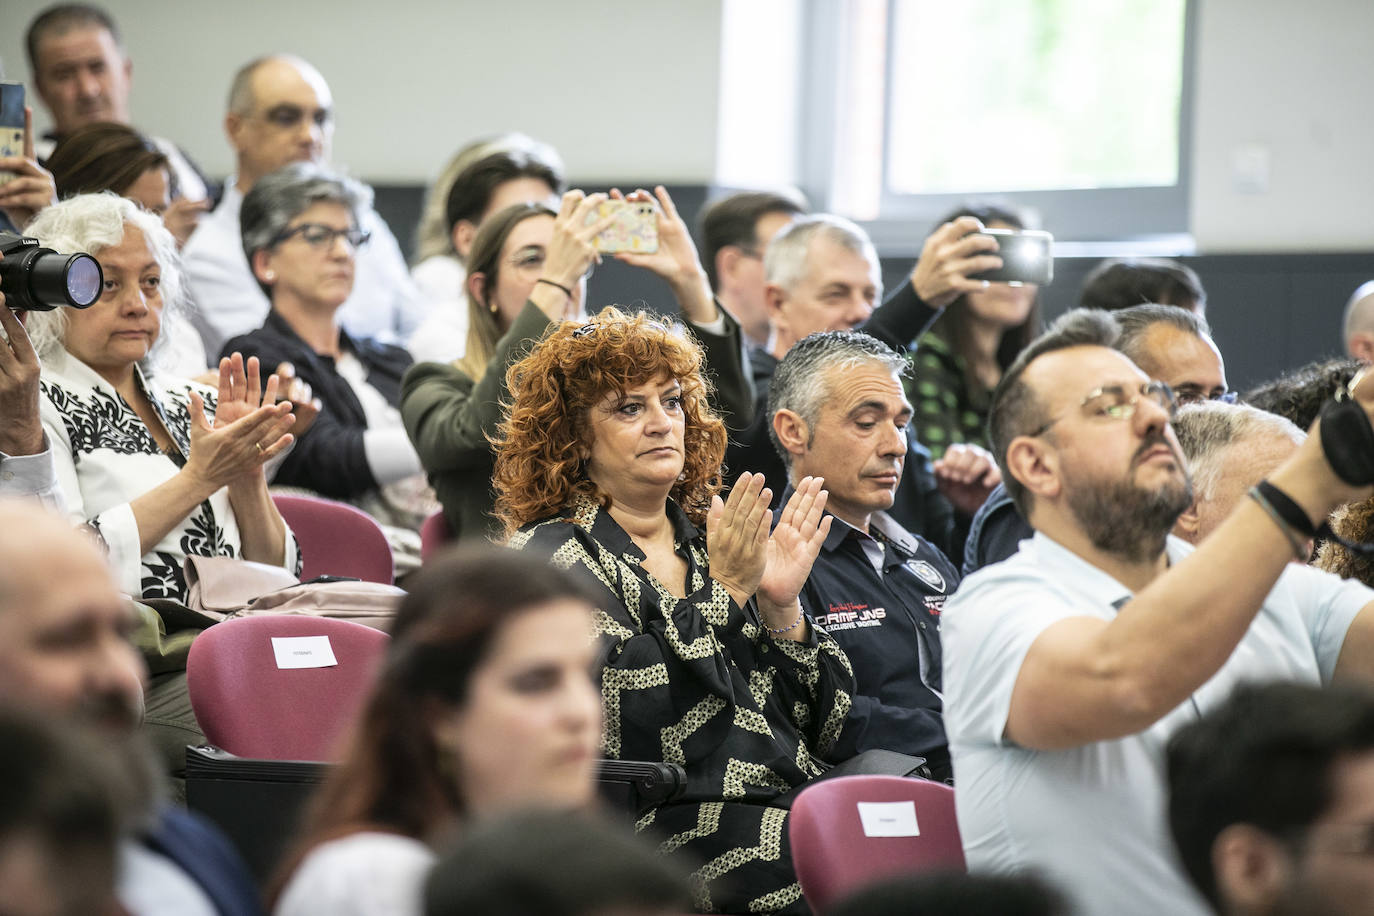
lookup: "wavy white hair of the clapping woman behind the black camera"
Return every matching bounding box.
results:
[25,191,186,369]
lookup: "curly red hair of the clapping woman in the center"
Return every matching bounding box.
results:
[492,306,725,537]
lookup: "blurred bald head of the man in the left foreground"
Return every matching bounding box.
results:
[0,500,143,731]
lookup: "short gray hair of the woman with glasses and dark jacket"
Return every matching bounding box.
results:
[239,162,372,289]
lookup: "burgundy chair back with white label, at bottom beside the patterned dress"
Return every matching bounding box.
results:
[787,776,966,915]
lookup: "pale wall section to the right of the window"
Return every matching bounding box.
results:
[1190,0,1374,253]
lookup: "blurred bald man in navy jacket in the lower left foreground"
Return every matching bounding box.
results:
[0,500,261,916]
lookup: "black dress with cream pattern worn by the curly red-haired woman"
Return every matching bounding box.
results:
[511,500,853,913]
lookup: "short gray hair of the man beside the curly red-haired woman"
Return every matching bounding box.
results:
[765,331,907,472]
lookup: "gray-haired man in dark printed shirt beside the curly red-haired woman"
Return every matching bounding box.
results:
[768,331,959,779]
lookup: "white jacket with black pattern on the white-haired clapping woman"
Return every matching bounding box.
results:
[40,350,301,600]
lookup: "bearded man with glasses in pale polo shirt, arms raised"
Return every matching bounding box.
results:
[941,310,1374,916]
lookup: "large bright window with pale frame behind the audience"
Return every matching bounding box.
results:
[801,0,1193,250]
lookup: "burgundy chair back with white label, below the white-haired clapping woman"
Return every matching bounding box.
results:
[185,614,389,761]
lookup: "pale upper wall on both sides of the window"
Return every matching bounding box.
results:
[0,0,1374,253]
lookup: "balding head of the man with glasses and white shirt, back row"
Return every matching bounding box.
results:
[224,55,334,192]
